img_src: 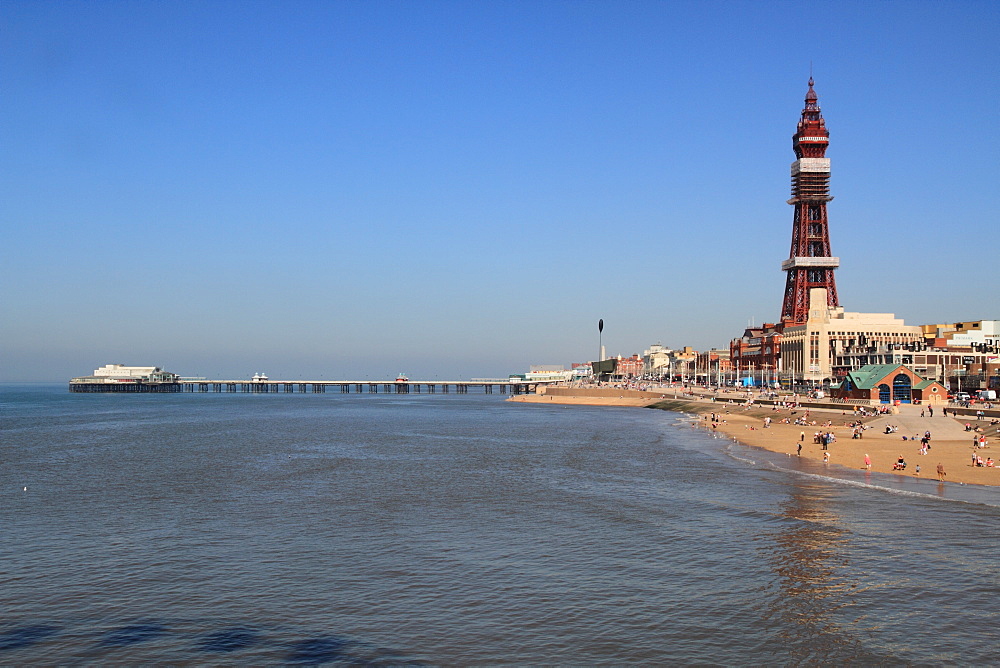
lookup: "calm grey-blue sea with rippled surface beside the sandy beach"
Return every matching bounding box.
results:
[0,385,1000,665]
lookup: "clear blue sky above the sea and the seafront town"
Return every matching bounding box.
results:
[0,0,1000,381]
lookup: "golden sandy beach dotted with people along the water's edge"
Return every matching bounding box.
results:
[508,387,1000,486]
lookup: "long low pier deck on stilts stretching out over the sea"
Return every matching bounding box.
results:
[69,379,545,394]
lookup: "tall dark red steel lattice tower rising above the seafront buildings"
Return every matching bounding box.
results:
[781,77,840,326]
